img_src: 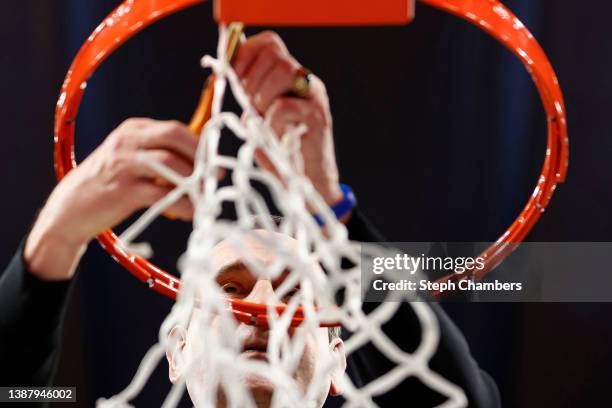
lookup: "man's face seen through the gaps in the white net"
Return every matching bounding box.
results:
[168,230,346,407]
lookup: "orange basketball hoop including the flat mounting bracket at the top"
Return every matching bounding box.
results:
[55,0,568,310]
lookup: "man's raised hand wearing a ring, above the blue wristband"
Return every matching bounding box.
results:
[233,31,342,205]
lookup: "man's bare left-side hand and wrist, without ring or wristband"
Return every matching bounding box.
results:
[24,118,198,281]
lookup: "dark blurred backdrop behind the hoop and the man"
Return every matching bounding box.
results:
[0,0,612,407]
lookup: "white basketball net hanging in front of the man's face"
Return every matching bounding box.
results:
[98,27,466,408]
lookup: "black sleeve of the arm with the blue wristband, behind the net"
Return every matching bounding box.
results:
[347,210,501,408]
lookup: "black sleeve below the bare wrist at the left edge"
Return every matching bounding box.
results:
[0,243,72,386]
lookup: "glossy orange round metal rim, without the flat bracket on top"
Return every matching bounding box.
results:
[54,0,569,326]
